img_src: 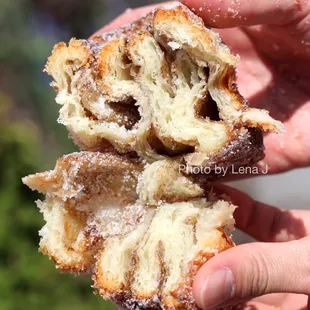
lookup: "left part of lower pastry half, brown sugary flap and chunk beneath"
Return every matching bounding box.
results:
[23,152,146,272]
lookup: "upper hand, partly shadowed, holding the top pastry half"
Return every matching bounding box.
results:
[92,0,310,173]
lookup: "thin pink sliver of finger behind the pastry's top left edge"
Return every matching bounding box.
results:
[92,2,176,37]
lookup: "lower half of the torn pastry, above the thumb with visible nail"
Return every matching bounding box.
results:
[23,152,235,309]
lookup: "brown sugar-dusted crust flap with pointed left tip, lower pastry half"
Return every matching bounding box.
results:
[23,152,144,206]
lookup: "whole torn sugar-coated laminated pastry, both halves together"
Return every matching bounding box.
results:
[23,4,283,310]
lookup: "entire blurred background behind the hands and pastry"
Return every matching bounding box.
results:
[0,0,310,310]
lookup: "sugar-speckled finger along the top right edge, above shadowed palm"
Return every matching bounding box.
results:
[182,0,309,28]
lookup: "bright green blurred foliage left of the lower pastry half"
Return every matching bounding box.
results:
[0,93,117,310]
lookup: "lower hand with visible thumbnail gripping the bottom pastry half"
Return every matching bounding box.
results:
[193,185,310,310]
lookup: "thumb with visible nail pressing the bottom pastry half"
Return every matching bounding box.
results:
[193,237,310,309]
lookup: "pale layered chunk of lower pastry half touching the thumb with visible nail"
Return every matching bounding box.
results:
[94,199,235,309]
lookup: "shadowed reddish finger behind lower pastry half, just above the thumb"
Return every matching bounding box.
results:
[215,184,310,242]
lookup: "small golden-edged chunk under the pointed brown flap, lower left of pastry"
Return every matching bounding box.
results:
[38,201,101,273]
